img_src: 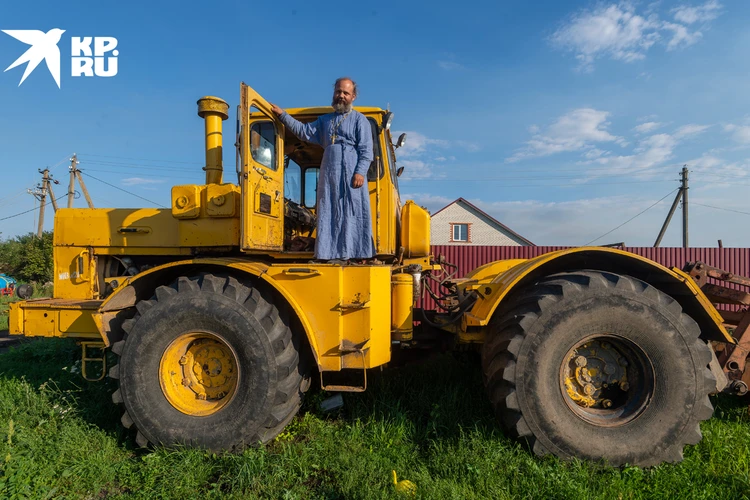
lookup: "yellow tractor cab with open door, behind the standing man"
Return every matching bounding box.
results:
[236,83,403,258]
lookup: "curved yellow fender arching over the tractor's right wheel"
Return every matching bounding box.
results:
[462,247,735,344]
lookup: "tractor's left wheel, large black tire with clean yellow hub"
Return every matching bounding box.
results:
[110,274,309,451]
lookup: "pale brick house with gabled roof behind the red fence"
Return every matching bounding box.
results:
[430,198,534,246]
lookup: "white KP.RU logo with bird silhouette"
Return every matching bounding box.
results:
[2,28,120,88]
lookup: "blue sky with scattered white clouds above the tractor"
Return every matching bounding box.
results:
[0,0,750,247]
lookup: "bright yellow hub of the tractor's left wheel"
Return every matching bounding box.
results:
[159,332,238,416]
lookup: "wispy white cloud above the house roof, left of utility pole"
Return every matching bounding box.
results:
[506,108,625,162]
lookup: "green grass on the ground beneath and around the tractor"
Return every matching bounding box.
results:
[0,339,750,499]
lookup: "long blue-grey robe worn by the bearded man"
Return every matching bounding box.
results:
[280,110,375,260]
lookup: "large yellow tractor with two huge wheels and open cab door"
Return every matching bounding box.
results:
[10,83,744,465]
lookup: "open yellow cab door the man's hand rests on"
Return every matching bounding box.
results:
[240,82,284,252]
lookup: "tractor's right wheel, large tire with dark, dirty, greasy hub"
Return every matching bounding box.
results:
[482,271,715,466]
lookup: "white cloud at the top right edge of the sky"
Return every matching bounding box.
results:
[550,0,721,72]
